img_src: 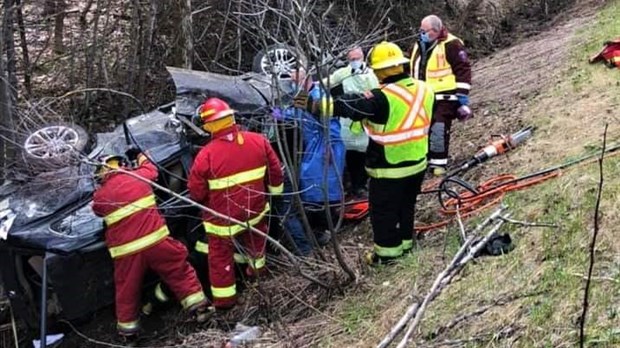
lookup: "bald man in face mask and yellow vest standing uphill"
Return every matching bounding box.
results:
[409,15,473,175]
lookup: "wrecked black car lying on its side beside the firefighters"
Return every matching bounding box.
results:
[0,68,294,328]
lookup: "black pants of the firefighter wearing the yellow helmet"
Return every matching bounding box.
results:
[369,171,424,257]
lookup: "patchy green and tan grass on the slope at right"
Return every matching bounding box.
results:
[324,0,620,347]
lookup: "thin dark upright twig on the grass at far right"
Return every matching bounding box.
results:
[579,124,609,348]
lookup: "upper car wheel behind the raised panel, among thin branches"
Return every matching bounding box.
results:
[252,45,307,78]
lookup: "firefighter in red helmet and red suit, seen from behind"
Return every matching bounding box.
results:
[188,98,283,309]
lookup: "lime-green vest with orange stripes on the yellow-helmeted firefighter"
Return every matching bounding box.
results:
[364,78,435,178]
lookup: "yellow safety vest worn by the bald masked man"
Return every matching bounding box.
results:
[409,34,463,93]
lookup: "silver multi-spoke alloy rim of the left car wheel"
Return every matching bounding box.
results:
[24,125,80,159]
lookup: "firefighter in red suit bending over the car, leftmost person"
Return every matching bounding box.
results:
[93,154,207,342]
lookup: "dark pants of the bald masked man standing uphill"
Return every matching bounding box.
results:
[428,100,459,166]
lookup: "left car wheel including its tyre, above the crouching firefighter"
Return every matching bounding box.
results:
[23,123,89,170]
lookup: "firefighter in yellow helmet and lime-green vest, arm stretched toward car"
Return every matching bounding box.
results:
[309,41,435,264]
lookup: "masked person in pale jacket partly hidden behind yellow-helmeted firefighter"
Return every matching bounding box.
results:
[323,47,379,197]
